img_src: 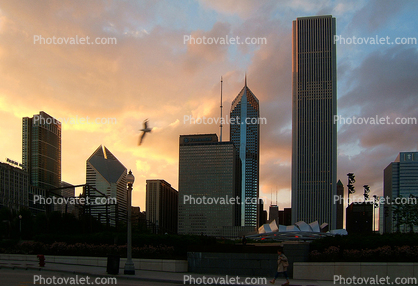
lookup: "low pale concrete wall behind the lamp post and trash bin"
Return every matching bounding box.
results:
[0,254,188,272]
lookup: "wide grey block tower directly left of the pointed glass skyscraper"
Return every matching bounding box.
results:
[177,134,241,237]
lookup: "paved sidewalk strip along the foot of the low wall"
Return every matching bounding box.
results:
[0,260,342,286]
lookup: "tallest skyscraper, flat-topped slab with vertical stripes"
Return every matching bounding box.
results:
[292,16,337,229]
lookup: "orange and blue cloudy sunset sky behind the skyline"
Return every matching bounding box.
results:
[0,0,418,210]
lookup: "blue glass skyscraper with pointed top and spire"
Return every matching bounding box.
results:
[230,78,260,227]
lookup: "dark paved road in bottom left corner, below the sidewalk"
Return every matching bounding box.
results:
[0,268,176,286]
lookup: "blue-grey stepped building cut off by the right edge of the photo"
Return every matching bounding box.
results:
[382,152,418,233]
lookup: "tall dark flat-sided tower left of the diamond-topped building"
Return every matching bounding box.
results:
[22,111,61,189]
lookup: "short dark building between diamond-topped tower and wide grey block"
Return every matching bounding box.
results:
[146,180,179,234]
